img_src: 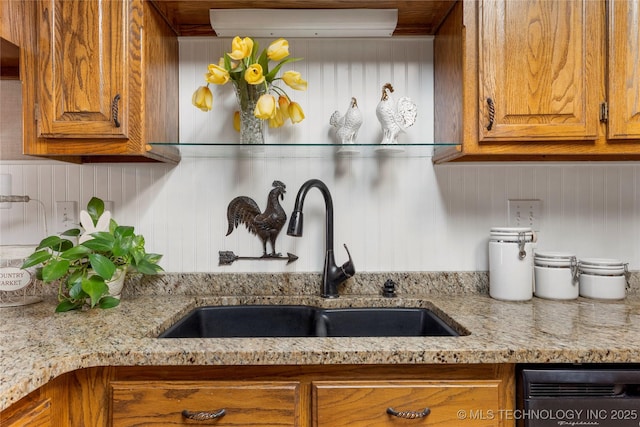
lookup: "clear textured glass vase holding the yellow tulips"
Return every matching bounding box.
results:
[234,81,267,144]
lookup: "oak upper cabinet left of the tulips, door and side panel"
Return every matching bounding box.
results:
[24,0,179,163]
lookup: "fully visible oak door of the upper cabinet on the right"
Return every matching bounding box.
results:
[478,0,604,142]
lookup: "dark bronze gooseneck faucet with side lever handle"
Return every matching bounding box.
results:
[287,179,356,298]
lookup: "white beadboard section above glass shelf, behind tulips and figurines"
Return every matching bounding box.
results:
[180,37,433,149]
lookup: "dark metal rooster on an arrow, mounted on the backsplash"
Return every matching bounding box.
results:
[218,181,298,265]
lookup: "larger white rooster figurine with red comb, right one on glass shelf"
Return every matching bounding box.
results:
[376,83,418,144]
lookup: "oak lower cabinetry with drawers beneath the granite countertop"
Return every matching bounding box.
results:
[0,364,515,427]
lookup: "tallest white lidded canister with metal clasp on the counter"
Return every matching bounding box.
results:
[489,227,536,301]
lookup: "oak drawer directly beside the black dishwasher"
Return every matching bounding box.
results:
[312,380,507,427]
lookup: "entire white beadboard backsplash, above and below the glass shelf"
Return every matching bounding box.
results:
[0,38,640,272]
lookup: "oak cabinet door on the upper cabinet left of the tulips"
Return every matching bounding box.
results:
[38,0,133,138]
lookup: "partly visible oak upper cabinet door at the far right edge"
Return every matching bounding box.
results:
[607,0,640,140]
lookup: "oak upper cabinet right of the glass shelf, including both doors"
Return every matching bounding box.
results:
[434,0,640,162]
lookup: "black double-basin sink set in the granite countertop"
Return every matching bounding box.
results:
[159,305,460,338]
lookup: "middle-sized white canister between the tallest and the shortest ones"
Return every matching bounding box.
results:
[533,251,580,300]
